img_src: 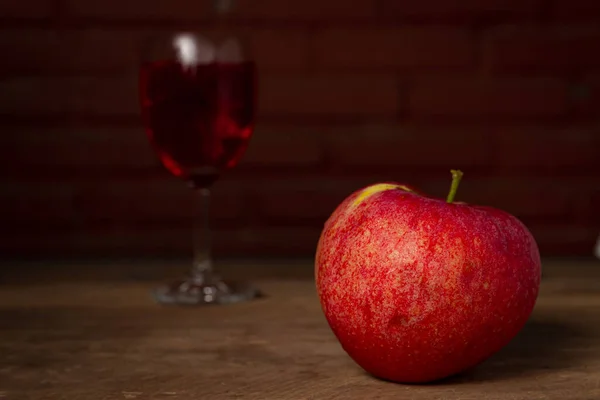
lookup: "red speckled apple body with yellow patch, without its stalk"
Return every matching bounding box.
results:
[315,183,541,383]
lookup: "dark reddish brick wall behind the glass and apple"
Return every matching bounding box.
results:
[0,0,600,256]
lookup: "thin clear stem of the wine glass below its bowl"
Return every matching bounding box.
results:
[192,188,213,283]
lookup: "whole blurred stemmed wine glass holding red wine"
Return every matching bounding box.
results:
[139,32,260,304]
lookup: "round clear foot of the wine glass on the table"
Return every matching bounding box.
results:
[153,276,262,305]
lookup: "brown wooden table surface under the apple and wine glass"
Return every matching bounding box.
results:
[0,261,600,400]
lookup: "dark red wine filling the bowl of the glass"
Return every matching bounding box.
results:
[140,60,256,188]
